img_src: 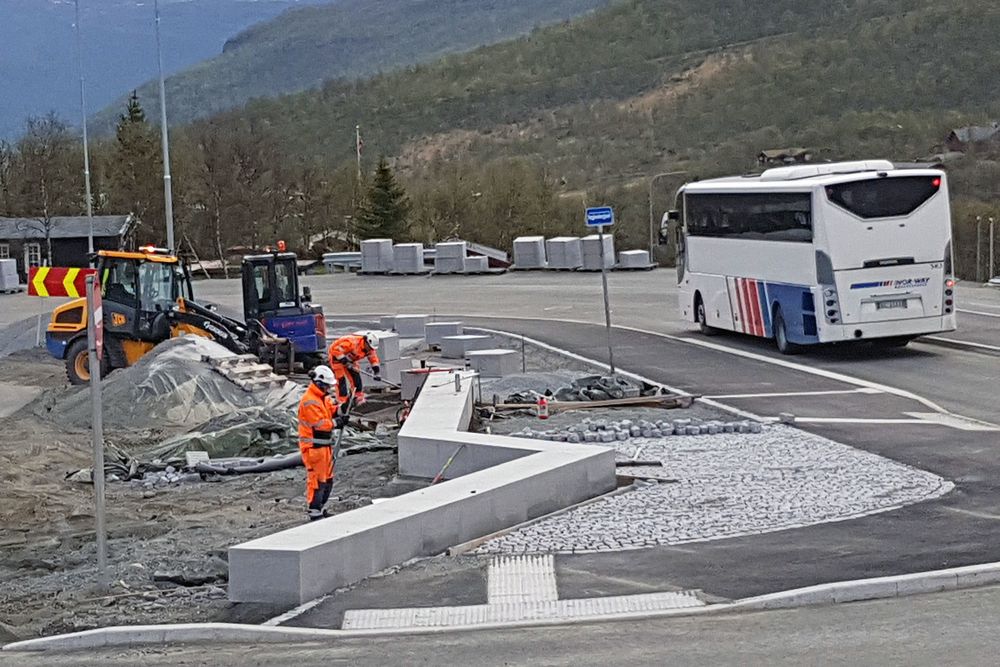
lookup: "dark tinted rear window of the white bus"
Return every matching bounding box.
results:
[826,176,941,219]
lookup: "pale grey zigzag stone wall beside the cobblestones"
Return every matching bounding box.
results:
[229,373,615,604]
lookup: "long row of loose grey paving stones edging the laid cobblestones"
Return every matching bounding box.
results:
[511,418,763,443]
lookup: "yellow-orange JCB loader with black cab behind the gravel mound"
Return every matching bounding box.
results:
[45,246,254,384]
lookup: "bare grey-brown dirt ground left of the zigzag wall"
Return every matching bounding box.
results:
[0,350,409,643]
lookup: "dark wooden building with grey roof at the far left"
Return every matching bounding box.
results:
[0,214,137,282]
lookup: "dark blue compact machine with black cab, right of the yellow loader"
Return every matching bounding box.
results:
[241,252,326,370]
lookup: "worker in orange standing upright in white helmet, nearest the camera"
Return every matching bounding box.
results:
[299,366,347,521]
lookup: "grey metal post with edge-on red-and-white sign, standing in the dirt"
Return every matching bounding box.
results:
[87,274,108,586]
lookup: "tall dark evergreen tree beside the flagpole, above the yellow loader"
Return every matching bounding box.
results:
[108,91,163,242]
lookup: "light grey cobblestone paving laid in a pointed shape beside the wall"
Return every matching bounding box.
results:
[476,425,953,554]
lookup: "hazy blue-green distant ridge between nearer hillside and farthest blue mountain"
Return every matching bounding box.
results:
[98,0,609,127]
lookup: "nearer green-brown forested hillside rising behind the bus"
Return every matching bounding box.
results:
[7,0,1000,277]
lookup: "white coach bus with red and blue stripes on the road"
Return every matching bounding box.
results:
[661,160,955,354]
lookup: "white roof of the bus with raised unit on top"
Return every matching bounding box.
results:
[681,160,944,192]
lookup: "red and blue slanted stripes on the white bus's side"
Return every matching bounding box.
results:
[726,278,819,344]
